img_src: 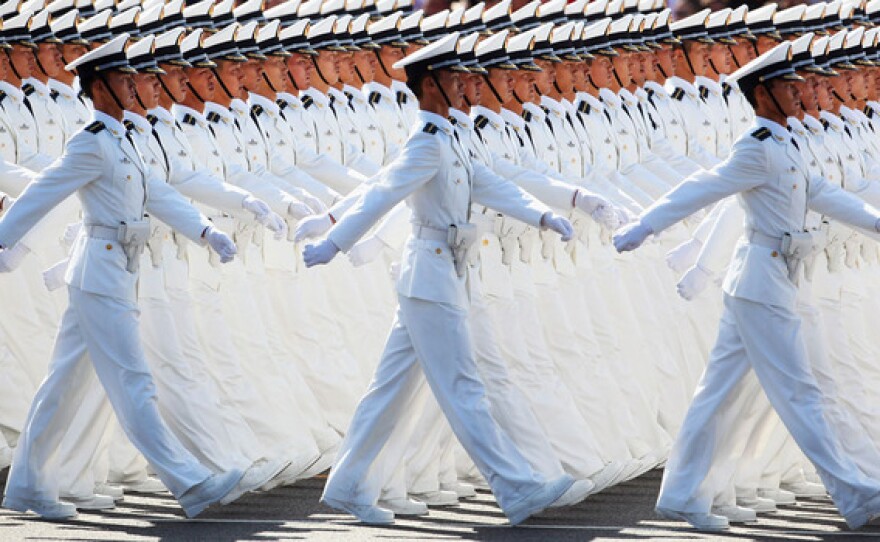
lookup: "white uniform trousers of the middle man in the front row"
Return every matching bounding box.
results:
[324,296,545,509]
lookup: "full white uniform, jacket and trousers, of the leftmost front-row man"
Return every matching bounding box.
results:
[0,112,210,501]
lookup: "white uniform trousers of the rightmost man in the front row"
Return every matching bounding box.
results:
[657,296,880,525]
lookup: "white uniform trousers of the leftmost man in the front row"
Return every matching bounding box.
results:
[6,287,211,500]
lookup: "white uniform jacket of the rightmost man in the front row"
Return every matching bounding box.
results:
[641,117,880,307]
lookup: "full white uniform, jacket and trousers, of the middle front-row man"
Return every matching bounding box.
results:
[324,111,560,514]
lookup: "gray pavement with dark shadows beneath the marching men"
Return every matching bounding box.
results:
[0,471,880,542]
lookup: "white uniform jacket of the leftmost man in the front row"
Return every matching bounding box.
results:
[0,112,211,301]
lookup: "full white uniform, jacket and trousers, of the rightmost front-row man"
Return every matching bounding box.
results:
[641,117,880,527]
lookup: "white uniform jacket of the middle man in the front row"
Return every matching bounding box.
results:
[328,111,549,307]
